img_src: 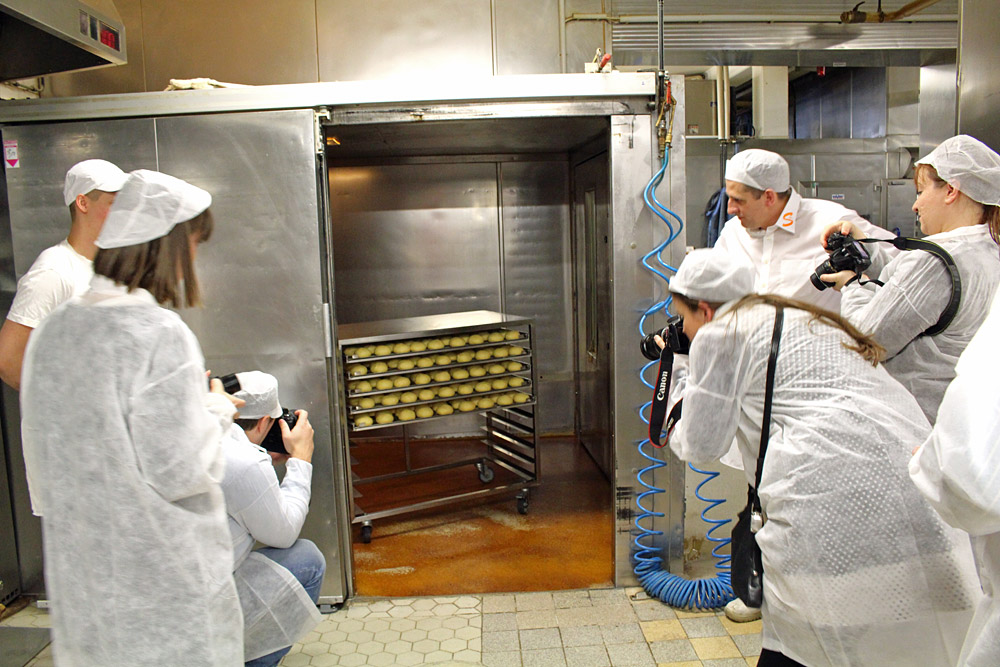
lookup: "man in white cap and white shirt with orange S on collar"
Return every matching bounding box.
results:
[715,148,896,313]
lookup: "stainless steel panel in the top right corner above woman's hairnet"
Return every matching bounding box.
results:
[958,0,1000,150]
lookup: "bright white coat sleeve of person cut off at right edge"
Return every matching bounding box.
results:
[910,299,1000,535]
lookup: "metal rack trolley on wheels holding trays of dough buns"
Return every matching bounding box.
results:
[339,310,540,543]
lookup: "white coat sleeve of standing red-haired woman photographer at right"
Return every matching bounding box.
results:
[840,251,951,359]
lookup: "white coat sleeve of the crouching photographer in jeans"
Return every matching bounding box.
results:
[234,457,312,549]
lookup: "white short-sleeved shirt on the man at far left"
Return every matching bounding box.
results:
[7,239,94,329]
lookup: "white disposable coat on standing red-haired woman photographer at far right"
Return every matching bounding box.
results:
[840,225,1000,423]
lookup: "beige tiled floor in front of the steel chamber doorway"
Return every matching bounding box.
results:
[3,588,760,667]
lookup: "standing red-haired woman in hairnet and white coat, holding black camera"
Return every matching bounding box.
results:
[822,135,1000,424]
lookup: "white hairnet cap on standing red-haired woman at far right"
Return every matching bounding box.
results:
[917,134,1000,206]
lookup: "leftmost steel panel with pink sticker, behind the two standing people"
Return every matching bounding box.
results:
[2,120,156,595]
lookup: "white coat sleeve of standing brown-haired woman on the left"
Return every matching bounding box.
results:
[126,327,232,502]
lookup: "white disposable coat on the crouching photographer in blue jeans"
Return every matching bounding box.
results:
[222,424,322,660]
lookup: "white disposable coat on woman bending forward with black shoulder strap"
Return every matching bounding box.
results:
[670,305,981,667]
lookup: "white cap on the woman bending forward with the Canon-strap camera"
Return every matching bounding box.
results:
[670,248,754,303]
